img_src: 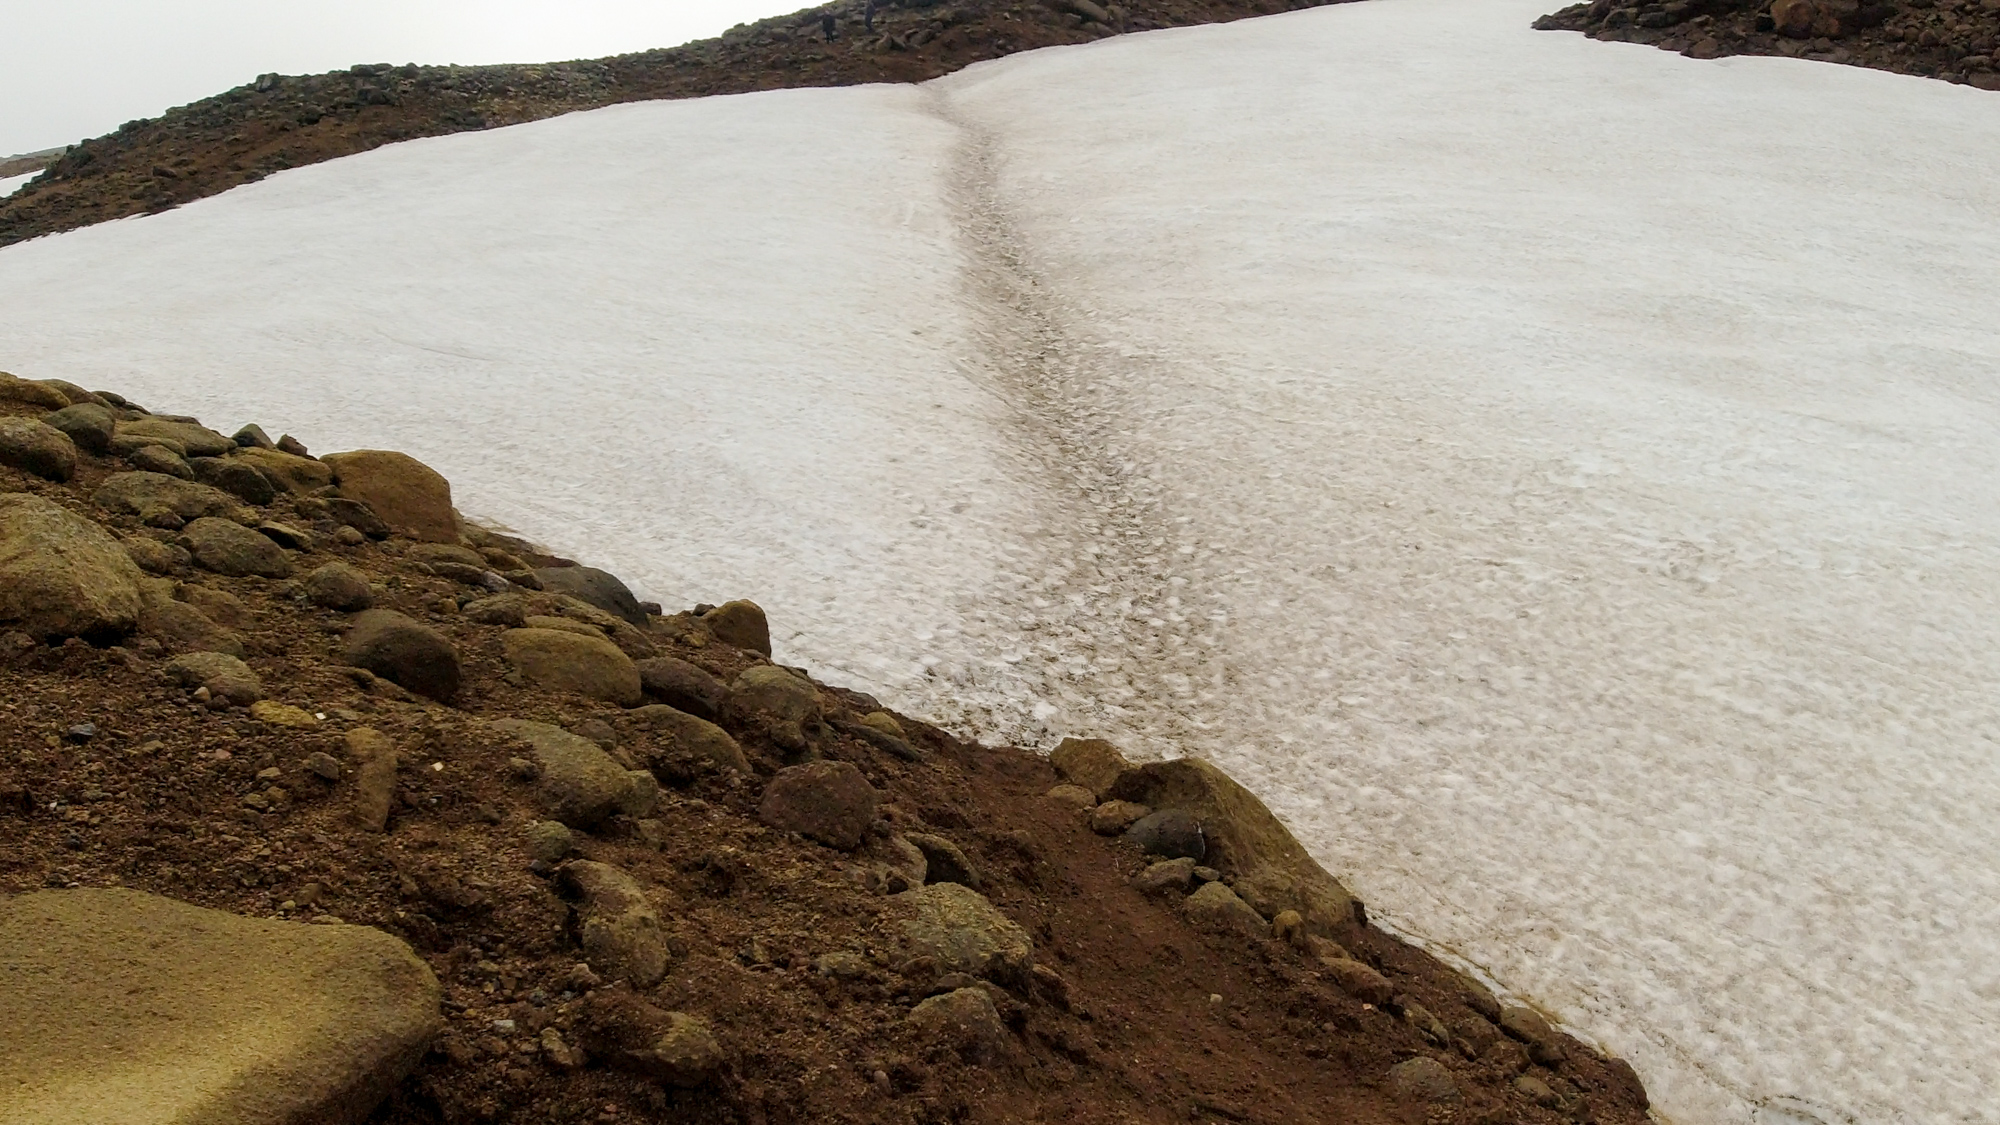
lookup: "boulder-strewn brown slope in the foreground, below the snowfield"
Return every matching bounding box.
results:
[0,364,1646,1125]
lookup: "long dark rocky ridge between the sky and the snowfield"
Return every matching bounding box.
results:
[0,0,1332,246]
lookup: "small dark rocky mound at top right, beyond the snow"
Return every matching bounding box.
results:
[1534,0,2000,90]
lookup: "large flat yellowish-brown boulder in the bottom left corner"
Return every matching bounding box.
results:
[0,889,438,1125]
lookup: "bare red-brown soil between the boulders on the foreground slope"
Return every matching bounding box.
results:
[0,378,1646,1125]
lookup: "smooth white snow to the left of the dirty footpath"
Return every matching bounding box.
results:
[0,86,1072,728]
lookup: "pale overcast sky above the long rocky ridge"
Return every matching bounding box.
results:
[0,0,810,156]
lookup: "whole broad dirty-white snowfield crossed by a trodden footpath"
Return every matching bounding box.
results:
[0,0,2000,1125]
